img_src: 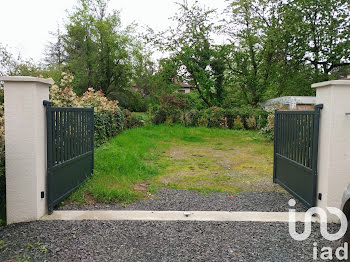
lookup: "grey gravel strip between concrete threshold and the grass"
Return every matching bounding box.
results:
[58,188,306,212]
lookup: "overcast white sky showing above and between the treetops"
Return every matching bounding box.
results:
[0,0,226,61]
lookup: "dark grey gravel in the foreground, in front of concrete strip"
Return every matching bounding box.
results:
[0,221,341,262]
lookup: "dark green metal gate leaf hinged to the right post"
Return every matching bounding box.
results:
[273,105,323,207]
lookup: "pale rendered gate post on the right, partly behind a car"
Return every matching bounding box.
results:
[312,80,350,221]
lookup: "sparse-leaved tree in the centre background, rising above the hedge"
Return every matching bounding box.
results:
[159,1,225,107]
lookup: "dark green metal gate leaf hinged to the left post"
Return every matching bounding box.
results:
[44,101,94,214]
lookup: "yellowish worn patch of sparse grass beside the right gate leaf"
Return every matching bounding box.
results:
[157,141,283,193]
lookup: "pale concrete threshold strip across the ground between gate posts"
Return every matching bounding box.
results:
[41,210,318,222]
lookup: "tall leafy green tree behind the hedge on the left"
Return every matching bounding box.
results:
[64,0,132,97]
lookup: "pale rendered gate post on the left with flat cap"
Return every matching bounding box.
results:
[0,76,53,224]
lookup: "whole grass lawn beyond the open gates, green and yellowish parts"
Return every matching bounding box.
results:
[68,125,280,204]
